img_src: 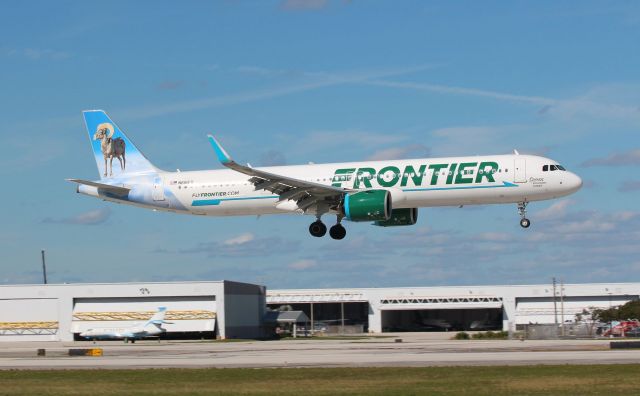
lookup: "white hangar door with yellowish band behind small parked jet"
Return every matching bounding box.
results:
[71,296,216,333]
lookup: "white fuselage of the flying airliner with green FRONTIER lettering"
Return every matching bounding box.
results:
[79,154,582,216]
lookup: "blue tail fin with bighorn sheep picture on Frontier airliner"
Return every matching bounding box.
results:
[82,110,158,179]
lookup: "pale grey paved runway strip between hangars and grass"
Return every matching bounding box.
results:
[0,335,640,369]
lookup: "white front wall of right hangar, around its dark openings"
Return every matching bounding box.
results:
[267,283,640,333]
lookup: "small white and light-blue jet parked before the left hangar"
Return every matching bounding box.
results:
[80,307,171,344]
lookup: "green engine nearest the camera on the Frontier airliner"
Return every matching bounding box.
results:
[343,190,391,221]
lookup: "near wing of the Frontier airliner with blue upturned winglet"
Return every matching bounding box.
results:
[208,135,352,211]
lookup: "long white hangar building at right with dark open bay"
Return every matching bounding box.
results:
[267,283,640,333]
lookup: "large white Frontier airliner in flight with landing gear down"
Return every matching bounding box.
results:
[67,110,582,240]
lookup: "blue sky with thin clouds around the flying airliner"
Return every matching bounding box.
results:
[0,0,640,288]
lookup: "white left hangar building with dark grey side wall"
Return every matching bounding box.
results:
[0,281,265,341]
